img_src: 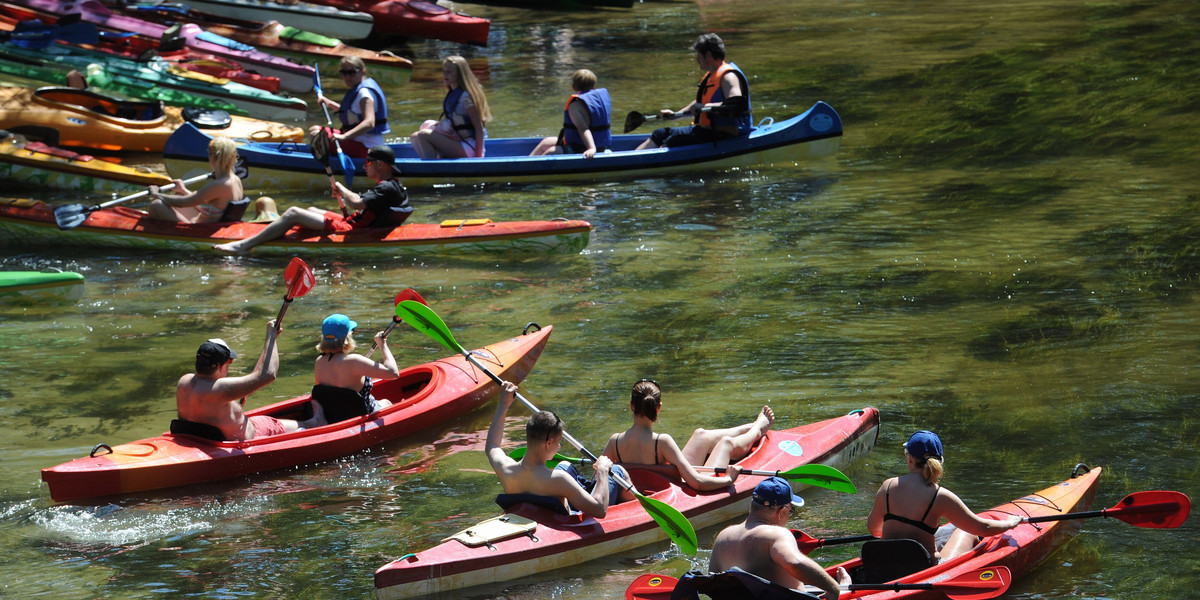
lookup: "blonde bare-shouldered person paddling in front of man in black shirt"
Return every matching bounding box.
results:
[148,137,250,223]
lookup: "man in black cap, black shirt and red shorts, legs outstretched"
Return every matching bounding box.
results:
[212,144,413,254]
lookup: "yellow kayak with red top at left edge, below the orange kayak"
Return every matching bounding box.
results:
[0,132,170,190]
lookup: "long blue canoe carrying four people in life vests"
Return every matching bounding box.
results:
[163,102,841,191]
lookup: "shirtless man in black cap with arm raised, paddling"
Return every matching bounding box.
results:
[175,319,314,440]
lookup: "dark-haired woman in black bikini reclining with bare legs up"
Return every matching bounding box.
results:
[604,379,775,491]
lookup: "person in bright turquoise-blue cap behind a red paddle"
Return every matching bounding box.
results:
[312,313,400,422]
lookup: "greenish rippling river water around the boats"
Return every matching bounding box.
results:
[0,0,1200,600]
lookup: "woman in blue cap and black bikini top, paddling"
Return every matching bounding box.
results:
[866,430,1021,564]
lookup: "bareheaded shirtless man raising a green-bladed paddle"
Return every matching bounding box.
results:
[484,382,632,518]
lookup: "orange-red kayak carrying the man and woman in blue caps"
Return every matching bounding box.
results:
[828,467,1102,600]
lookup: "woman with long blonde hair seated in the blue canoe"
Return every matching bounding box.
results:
[413,56,492,158]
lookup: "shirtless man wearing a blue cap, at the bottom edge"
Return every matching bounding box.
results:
[708,476,850,600]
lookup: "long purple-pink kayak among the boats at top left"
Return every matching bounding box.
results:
[10,0,313,92]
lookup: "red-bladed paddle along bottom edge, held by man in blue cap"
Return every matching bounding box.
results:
[625,565,1013,600]
